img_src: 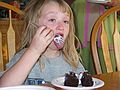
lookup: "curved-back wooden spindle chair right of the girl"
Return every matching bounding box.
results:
[90,6,120,74]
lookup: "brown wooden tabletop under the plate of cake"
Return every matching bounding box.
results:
[45,72,120,90]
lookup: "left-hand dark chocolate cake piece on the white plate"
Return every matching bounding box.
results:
[64,72,79,87]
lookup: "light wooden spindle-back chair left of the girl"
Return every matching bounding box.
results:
[0,2,24,71]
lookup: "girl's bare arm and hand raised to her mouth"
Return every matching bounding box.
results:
[0,26,54,86]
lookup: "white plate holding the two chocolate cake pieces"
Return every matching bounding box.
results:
[51,77,104,90]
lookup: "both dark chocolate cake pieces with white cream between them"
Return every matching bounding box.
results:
[64,72,94,87]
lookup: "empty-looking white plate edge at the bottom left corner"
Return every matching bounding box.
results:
[0,85,55,90]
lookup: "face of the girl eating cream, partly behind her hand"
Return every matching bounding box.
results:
[38,1,70,50]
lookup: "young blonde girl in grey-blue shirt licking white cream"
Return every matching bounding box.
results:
[0,0,84,86]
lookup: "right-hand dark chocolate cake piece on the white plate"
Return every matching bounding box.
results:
[81,72,94,87]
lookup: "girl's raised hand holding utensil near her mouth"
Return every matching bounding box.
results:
[29,26,54,54]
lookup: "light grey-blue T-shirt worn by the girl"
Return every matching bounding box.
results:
[7,49,85,84]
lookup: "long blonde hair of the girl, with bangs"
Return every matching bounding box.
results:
[21,0,80,68]
